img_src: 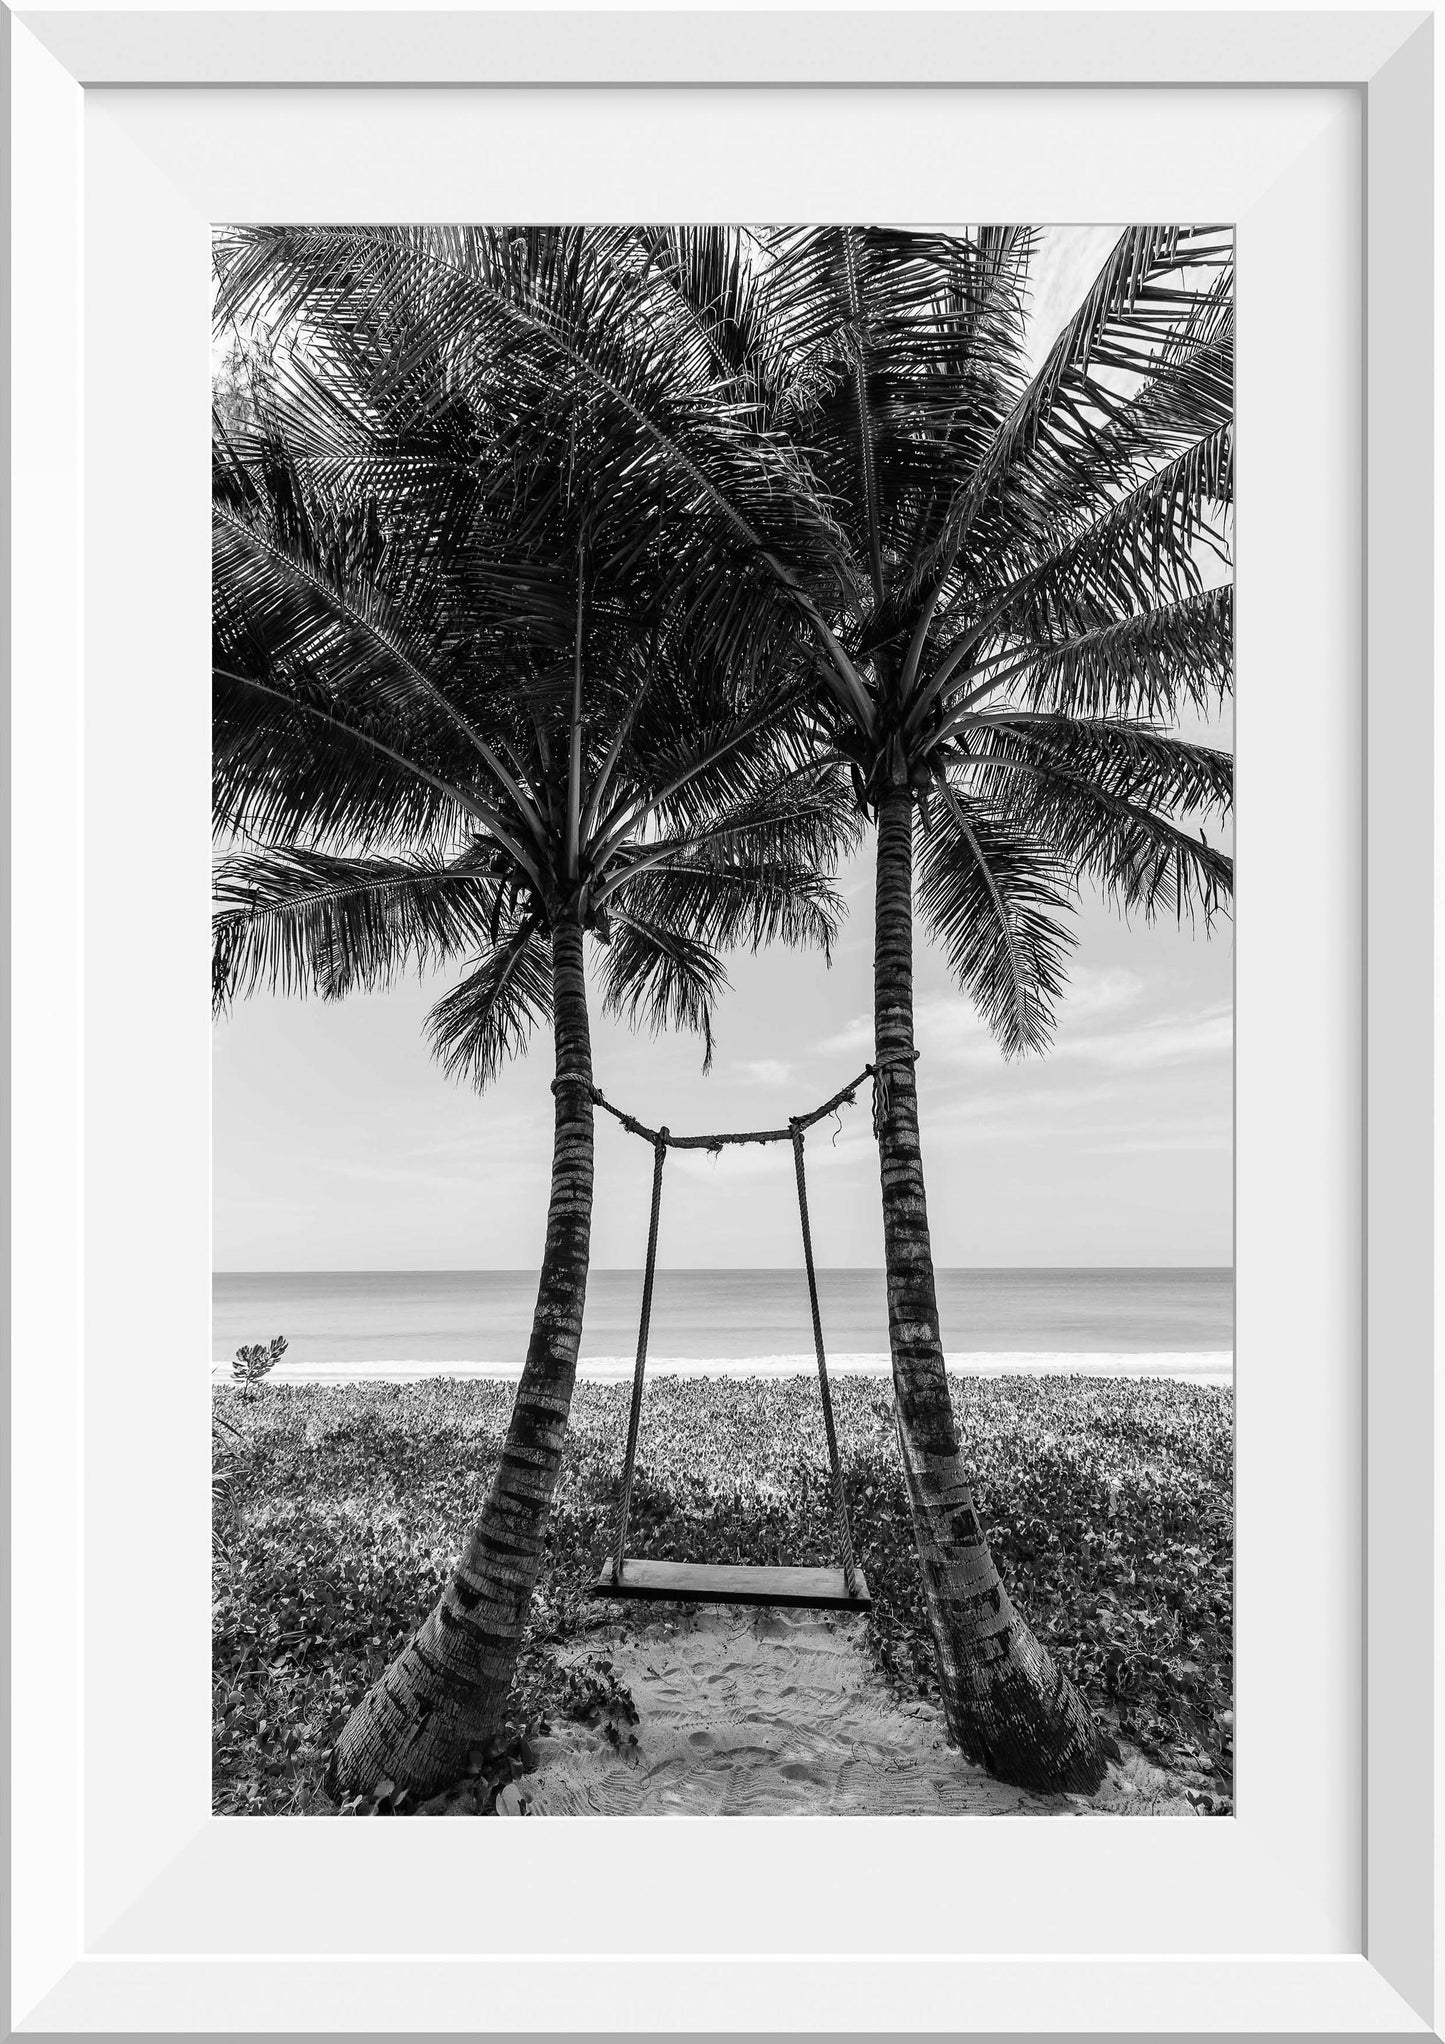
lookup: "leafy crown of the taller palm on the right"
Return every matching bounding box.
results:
[517,227,1234,1051]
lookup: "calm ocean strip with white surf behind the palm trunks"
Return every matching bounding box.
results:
[211,1269,1234,1380]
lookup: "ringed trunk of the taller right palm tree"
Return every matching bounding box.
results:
[873,785,1106,1793]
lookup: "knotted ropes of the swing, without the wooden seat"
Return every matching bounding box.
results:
[552,1051,918,1596]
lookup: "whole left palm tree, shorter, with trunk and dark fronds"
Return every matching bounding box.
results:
[213,235,850,1793]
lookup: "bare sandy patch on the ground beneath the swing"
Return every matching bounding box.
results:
[523,1607,1196,1817]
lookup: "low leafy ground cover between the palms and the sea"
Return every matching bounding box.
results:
[213,1376,1234,1815]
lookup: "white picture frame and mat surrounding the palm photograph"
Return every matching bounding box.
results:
[4,6,1441,2034]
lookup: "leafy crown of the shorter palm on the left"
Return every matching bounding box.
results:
[213,233,856,1081]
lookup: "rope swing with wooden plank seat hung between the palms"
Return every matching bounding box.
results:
[580,1051,918,1611]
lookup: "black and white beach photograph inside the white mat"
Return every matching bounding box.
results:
[209,221,1253,1823]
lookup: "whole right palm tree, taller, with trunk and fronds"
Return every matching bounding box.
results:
[652,227,1232,1791]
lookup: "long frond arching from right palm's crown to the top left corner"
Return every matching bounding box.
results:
[219,227,840,694]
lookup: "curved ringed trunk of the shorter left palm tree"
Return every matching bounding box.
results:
[331,922,593,1795]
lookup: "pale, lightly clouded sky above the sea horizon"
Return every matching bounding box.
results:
[213,229,1232,1269]
